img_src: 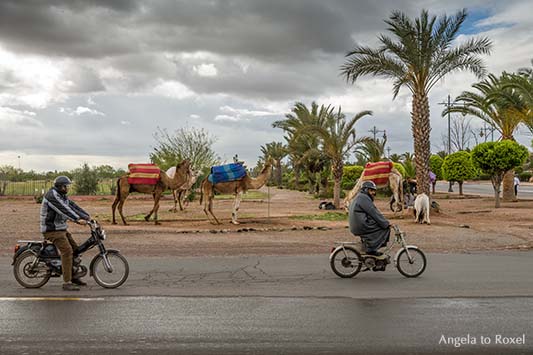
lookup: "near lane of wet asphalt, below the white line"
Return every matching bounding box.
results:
[0,297,533,354]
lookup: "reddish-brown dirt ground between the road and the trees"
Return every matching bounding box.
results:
[0,188,533,256]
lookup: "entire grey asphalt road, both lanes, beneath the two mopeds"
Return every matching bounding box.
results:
[0,252,533,354]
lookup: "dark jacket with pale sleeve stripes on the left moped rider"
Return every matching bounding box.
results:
[41,187,91,233]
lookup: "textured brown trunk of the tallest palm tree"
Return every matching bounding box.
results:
[411,92,431,196]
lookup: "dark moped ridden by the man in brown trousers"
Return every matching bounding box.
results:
[11,220,129,288]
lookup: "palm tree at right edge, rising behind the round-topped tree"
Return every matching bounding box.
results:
[443,73,532,201]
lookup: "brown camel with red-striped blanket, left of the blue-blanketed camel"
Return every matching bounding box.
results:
[112,159,191,225]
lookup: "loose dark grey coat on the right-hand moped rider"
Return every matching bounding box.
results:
[349,191,390,251]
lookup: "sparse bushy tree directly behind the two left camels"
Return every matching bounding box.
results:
[150,127,220,172]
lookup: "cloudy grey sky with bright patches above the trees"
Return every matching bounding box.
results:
[0,0,533,171]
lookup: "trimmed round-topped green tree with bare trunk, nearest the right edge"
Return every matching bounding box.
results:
[471,140,528,208]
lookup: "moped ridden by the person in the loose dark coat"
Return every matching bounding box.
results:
[329,225,427,278]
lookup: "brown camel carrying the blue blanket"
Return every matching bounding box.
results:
[200,158,274,224]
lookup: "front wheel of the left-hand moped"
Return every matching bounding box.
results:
[91,250,130,288]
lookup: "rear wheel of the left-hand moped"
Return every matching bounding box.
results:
[13,250,50,288]
